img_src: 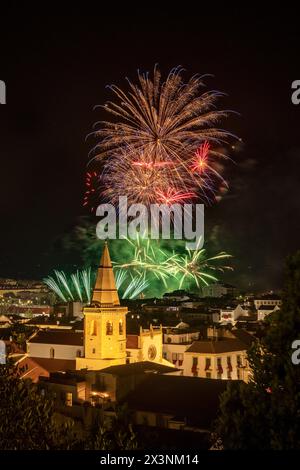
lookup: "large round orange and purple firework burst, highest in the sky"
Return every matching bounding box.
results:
[92,67,231,205]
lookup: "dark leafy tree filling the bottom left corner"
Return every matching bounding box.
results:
[0,364,77,450]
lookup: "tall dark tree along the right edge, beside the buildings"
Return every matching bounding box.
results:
[214,251,300,450]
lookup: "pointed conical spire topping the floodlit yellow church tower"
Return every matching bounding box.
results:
[92,242,120,306]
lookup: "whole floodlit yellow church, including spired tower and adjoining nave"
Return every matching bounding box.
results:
[18,244,172,378]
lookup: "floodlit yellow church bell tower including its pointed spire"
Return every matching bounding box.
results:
[76,242,127,370]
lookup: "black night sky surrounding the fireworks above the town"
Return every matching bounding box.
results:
[0,8,300,290]
